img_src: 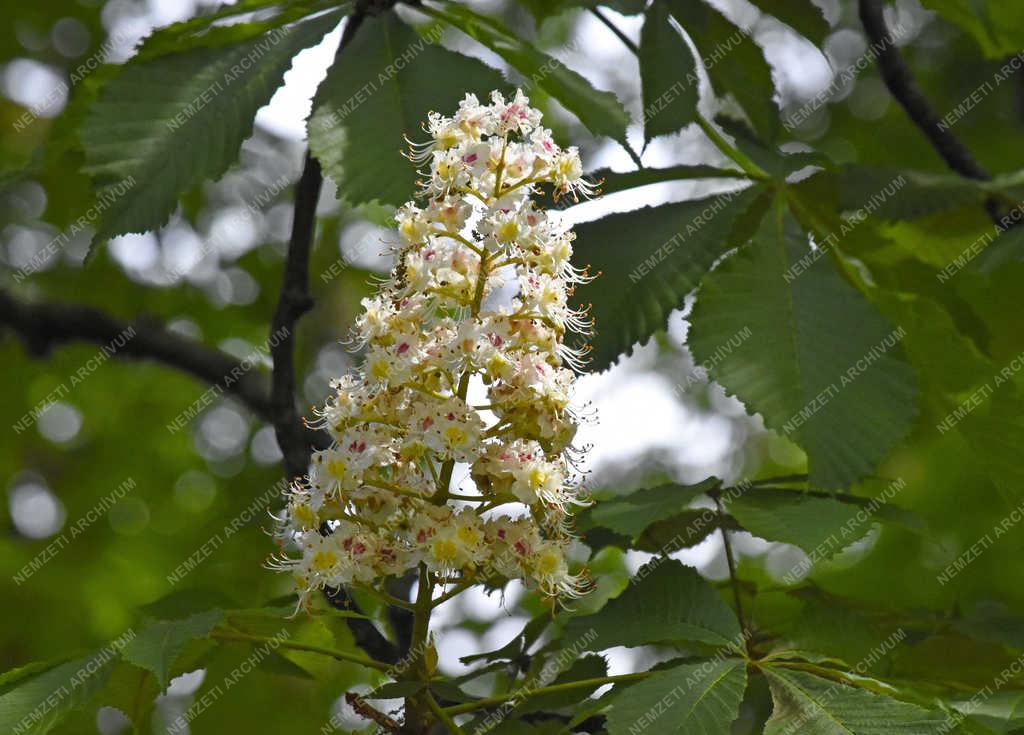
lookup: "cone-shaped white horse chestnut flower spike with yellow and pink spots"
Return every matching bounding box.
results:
[274,91,591,610]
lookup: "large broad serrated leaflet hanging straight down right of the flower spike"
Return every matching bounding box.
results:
[688,205,916,489]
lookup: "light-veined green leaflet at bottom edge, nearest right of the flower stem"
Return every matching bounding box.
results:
[608,658,746,735]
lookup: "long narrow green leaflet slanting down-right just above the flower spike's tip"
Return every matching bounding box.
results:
[423,3,630,149]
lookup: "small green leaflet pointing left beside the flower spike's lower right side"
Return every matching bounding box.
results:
[578,477,721,538]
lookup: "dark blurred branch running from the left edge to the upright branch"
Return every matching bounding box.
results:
[0,289,272,421]
